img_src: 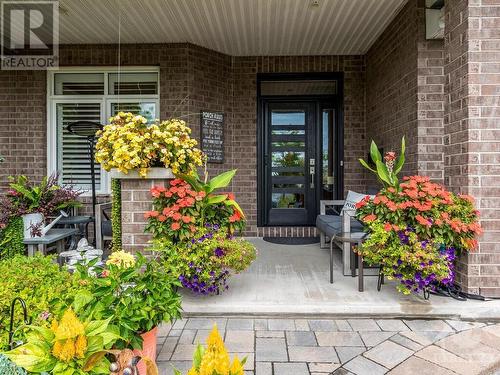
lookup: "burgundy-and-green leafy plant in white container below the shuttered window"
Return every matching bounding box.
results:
[0,174,82,237]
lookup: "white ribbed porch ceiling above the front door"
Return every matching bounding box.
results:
[56,0,406,56]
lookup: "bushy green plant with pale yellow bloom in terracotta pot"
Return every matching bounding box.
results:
[74,251,181,349]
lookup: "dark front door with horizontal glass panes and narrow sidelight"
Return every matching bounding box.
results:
[261,100,337,226]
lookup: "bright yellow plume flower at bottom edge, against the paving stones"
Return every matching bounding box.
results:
[174,325,246,375]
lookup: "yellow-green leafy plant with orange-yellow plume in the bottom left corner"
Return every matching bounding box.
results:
[5,308,119,375]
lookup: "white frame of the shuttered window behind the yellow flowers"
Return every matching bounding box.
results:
[47,66,160,196]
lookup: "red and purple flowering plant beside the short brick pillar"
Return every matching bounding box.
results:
[145,170,256,295]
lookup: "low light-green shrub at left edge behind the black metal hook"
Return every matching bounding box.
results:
[0,255,84,350]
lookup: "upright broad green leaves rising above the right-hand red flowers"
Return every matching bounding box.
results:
[359,137,406,186]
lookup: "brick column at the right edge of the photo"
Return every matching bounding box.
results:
[444,0,500,296]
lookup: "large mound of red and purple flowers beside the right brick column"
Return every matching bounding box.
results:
[356,140,481,293]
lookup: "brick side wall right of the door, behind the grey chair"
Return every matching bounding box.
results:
[366,0,444,184]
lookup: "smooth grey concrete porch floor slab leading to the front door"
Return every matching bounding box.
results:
[182,238,500,320]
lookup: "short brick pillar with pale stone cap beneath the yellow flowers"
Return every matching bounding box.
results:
[111,168,175,251]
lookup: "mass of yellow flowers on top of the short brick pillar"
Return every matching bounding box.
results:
[95,112,202,178]
